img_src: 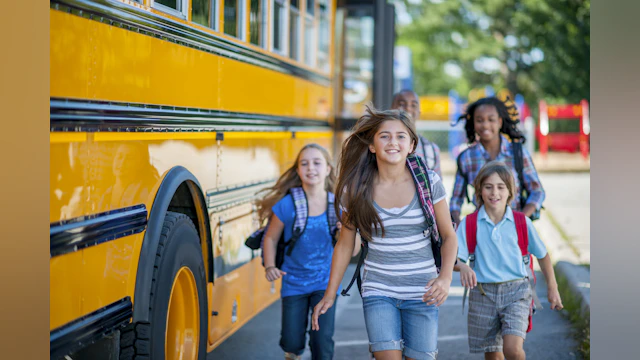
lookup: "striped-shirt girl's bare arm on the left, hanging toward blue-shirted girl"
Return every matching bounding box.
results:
[311,218,356,330]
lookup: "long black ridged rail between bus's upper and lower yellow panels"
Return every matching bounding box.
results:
[50,98,329,131]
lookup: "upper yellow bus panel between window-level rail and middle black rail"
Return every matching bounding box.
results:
[50,10,332,120]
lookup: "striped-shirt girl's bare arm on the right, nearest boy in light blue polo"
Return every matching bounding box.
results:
[422,200,458,306]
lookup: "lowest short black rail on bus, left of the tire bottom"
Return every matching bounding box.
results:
[49,296,133,359]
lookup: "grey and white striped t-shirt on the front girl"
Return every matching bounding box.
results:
[362,170,446,300]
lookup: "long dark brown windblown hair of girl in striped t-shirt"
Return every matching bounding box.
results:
[335,106,418,241]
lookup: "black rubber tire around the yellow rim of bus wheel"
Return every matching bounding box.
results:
[120,211,208,360]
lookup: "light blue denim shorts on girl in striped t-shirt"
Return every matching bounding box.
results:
[362,296,438,359]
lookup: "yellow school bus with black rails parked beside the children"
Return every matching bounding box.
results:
[49,0,392,359]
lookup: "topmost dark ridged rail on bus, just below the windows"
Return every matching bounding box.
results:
[50,0,331,86]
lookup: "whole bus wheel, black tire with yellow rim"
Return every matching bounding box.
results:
[120,212,207,360]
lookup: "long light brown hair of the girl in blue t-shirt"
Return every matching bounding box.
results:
[257,143,336,224]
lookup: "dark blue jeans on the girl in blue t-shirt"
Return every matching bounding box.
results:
[280,291,337,360]
